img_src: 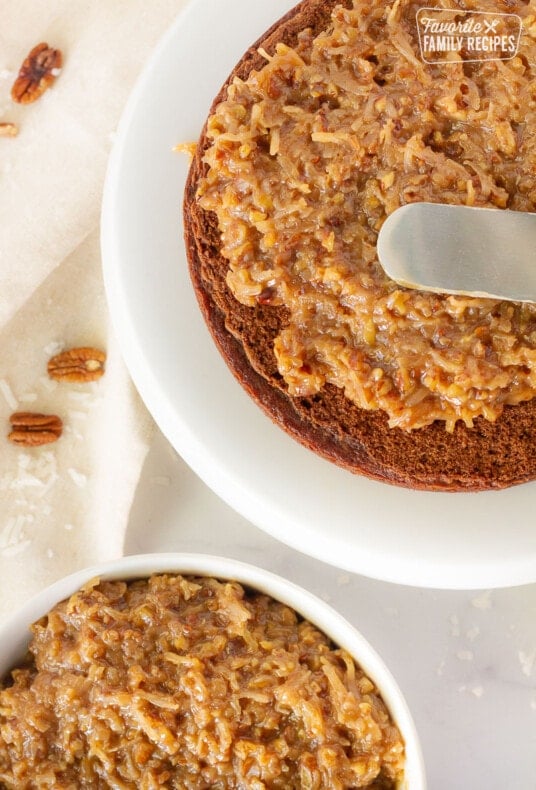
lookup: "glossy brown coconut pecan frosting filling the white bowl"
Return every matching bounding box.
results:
[0,575,404,790]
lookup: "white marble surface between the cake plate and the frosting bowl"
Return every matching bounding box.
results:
[126,434,536,790]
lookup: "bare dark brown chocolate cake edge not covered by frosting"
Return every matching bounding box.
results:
[184,0,536,491]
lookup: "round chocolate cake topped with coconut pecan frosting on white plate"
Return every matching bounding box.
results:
[184,0,536,491]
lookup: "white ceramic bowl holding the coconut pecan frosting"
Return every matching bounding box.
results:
[0,553,426,790]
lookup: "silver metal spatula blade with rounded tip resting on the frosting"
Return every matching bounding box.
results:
[377,203,536,302]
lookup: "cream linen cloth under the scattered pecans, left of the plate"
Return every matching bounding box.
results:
[0,0,187,621]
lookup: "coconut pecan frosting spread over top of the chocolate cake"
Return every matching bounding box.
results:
[199,0,536,431]
